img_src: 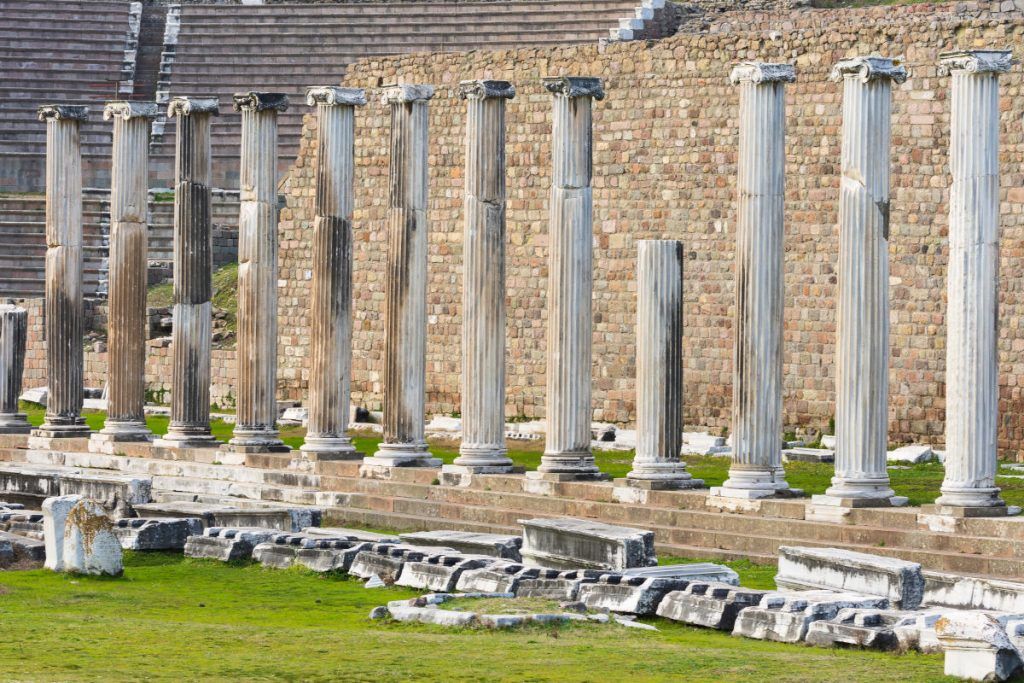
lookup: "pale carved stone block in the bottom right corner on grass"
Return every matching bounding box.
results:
[935,612,1024,681]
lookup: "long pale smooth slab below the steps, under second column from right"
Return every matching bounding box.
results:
[775,546,925,609]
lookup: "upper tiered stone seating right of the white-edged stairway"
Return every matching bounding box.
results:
[154,0,639,187]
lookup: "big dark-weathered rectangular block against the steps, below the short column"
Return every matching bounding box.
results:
[519,517,657,570]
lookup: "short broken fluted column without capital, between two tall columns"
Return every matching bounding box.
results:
[626,240,703,489]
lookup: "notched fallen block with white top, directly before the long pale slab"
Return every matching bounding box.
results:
[732,591,889,643]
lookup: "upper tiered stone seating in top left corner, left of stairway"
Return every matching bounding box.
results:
[0,0,129,190]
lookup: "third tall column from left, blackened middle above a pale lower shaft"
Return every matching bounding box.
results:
[156,97,219,447]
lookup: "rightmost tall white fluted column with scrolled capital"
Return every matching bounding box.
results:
[936,50,1014,515]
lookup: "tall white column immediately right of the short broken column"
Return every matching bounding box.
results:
[712,62,796,499]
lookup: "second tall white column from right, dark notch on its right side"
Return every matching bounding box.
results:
[812,56,906,507]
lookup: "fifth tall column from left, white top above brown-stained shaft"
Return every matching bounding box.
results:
[302,86,367,460]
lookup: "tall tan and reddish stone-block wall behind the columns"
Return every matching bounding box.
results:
[280,4,1024,456]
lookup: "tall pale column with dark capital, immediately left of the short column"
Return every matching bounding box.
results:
[527,77,605,481]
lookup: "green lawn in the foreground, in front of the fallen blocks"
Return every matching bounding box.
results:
[0,553,946,683]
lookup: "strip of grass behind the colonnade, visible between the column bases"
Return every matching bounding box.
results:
[22,402,1024,506]
